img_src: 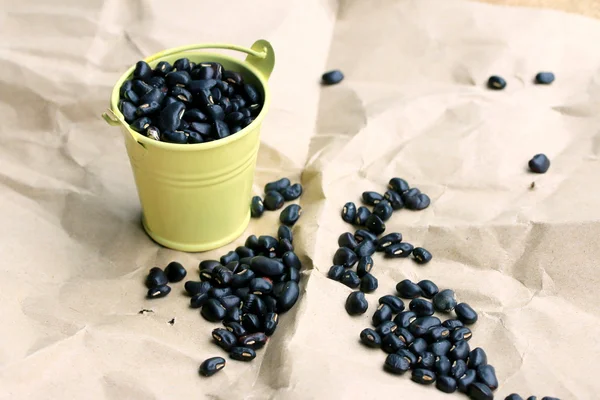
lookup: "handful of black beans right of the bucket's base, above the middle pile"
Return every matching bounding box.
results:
[250,178,302,222]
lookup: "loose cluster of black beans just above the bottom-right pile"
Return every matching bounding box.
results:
[328,178,432,293]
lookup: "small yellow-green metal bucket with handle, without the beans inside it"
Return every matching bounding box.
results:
[105,41,274,252]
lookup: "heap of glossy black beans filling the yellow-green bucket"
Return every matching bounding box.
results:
[119,58,263,144]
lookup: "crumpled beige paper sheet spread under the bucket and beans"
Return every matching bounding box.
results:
[0,0,600,400]
